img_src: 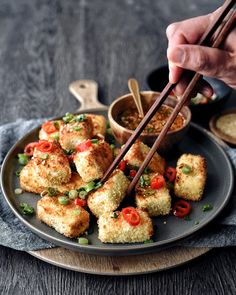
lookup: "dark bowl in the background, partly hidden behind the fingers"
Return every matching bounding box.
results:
[147,65,232,116]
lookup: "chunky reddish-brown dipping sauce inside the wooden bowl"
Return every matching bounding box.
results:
[119,105,184,133]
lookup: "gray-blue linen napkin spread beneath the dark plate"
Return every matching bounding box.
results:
[0,119,236,251]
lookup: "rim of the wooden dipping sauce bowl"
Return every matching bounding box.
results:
[108,90,192,137]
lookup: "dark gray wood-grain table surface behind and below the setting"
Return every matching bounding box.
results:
[0,0,236,295]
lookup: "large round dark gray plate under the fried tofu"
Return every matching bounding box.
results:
[1,111,234,255]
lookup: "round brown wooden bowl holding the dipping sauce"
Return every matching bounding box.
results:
[108,91,191,153]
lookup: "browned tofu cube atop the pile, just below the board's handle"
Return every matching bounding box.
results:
[59,115,93,150]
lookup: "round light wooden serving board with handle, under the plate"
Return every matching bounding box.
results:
[28,80,214,276]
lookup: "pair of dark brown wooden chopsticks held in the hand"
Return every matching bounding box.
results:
[101,0,236,195]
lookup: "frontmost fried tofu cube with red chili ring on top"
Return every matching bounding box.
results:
[98,209,153,243]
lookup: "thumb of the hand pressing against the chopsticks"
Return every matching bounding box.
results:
[167,44,231,79]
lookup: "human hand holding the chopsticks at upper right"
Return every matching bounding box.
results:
[166,8,236,97]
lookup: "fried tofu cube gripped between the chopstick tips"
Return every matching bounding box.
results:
[88,169,130,217]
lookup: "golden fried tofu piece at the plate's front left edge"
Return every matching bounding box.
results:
[37,196,89,238]
